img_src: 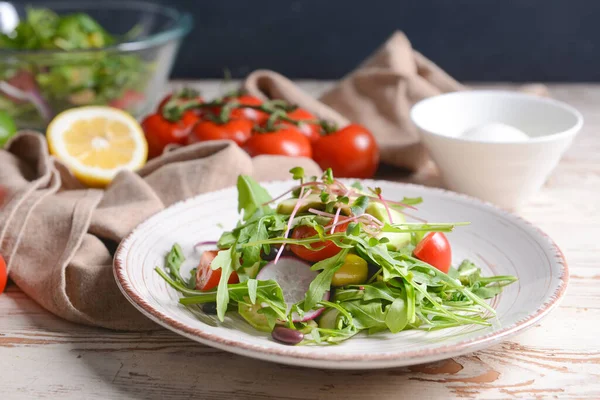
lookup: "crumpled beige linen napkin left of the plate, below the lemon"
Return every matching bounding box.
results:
[0,132,320,330]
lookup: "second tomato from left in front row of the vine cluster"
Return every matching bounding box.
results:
[188,119,254,146]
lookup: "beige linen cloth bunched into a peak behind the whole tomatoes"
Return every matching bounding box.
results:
[243,32,547,170]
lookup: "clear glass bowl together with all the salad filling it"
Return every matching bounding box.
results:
[0,1,191,129]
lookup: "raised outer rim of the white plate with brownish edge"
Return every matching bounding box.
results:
[113,179,569,369]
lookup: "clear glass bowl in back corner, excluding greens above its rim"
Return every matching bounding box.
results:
[0,1,192,129]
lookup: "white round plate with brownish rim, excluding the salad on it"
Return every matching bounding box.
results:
[114,181,568,369]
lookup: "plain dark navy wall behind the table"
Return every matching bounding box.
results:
[36,0,600,82]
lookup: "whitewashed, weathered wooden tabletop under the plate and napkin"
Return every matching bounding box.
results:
[0,82,600,400]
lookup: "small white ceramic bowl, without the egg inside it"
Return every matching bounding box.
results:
[411,90,583,209]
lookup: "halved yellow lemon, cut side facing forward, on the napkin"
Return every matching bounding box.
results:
[46,106,148,187]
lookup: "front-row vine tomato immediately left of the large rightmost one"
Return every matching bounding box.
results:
[244,127,312,158]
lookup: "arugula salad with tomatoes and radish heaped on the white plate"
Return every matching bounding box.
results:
[156,168,516,345]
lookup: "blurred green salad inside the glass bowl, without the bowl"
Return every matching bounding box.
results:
[0,8,151,125]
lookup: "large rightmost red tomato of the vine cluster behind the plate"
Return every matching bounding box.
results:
[313,124,379,178]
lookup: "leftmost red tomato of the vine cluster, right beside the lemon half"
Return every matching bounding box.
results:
[142,111,199,158]
